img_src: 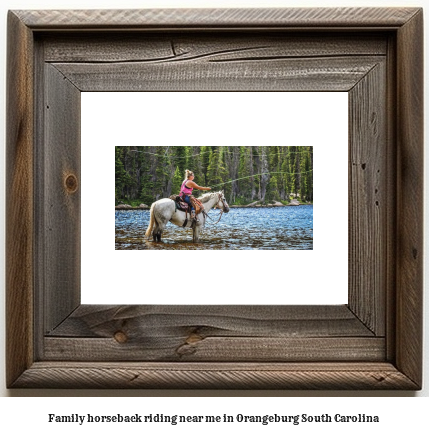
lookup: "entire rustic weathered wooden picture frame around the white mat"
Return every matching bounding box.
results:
[6,8,423,390]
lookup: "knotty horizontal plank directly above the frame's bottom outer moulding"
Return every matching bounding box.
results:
[44,336,386,364]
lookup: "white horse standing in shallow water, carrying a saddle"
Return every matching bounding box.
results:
[146,191,229,242]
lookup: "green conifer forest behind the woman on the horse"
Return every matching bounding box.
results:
[115,146,313,206]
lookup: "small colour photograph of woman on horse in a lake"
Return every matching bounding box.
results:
[115,146,313,250]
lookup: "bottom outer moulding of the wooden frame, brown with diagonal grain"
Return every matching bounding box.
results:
[10,362,416,390]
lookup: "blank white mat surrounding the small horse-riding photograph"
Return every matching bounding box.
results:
[81,92,348,304]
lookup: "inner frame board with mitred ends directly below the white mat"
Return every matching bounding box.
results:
[48,305,374,341]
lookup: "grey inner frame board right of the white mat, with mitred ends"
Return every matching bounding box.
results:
[349,62,389,336]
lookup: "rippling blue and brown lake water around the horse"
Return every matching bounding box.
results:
[115,205,313,250]
